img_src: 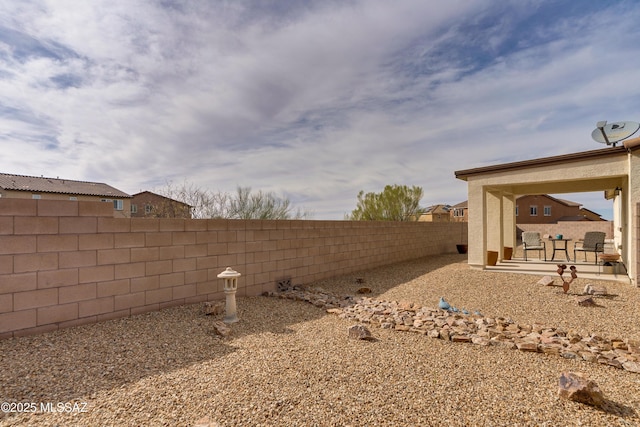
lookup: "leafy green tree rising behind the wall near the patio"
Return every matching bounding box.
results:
[347,185,422,221]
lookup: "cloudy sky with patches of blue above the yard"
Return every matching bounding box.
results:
[0,0,640,219]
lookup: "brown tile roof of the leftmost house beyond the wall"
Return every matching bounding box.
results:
[0,173,131,198]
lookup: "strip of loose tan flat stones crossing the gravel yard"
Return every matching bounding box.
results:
[265,287,640,373]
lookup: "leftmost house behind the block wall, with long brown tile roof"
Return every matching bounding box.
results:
[0,173,131,217]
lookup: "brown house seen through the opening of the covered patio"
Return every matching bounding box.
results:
[516,194,602,224]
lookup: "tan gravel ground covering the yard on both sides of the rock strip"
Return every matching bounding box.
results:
[0,255,640,426]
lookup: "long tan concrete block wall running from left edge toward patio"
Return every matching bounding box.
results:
[0,198,466,338]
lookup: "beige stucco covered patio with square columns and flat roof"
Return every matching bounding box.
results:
[455,143,640,286]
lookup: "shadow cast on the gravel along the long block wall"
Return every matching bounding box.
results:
[0,254,466,412]
